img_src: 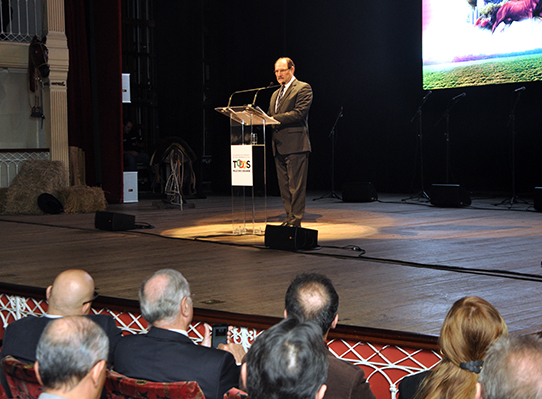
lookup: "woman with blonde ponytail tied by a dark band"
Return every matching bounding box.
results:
[399,296,508,399]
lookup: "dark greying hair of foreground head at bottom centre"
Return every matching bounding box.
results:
[246,317,328,399]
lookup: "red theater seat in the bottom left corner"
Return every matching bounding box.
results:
[2,356,42,399]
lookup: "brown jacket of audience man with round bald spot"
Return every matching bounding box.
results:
[324,353,375,399]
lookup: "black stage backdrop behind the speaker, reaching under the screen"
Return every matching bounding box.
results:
[155,0,542,197]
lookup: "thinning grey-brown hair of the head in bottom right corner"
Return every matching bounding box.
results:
[478,335,542,399]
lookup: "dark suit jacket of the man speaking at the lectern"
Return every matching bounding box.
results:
[268,79,312,155]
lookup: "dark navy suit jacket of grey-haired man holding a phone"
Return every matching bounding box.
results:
[115,327,239,399]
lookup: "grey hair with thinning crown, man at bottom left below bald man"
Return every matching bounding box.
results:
[36,316,109,391]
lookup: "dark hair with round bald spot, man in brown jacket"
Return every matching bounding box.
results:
[284,273,339,334]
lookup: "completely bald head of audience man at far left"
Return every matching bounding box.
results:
[48,269,94,316]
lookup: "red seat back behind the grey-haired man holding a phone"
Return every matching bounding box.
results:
[105,371,205,399]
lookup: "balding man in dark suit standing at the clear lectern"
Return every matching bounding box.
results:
[268,57,312,226]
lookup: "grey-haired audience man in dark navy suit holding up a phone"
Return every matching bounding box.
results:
[115,269,242,399]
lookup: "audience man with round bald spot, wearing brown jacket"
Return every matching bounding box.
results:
[284,273,375,399]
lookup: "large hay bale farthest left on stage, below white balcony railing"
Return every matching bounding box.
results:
[5,160,68,215]
